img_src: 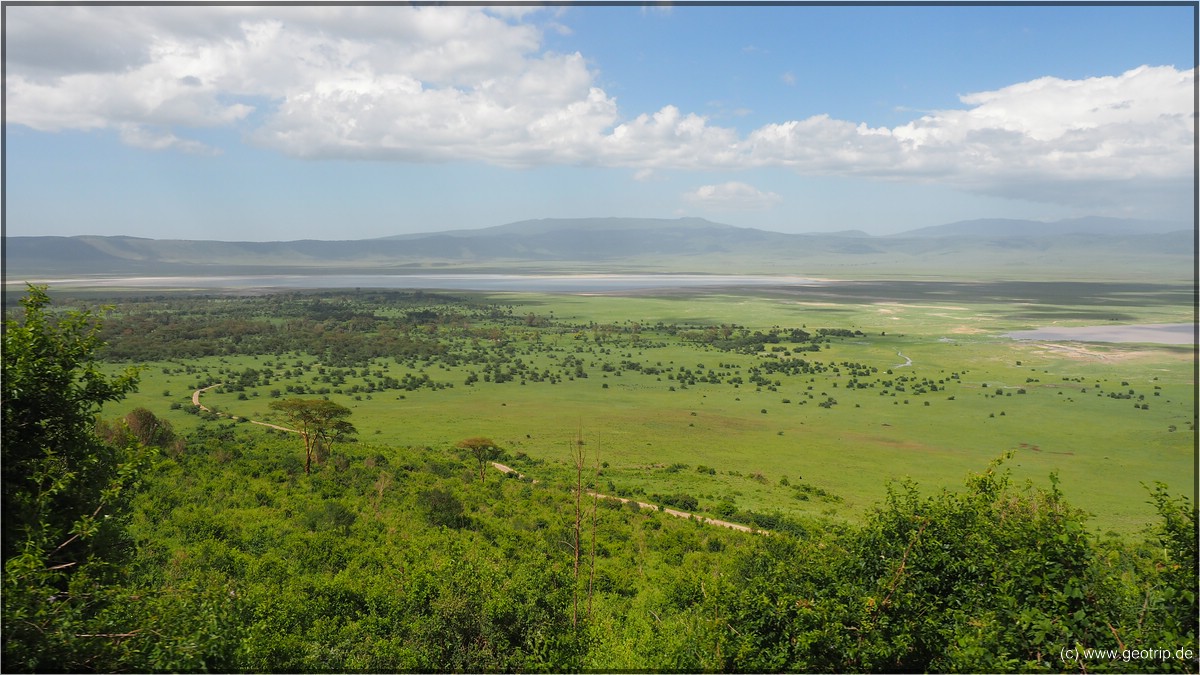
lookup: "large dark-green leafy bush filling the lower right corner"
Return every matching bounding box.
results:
[716,454,1196,673]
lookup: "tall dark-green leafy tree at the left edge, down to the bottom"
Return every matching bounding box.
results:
[2,286,151,670]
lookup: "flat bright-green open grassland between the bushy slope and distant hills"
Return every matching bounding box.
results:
[84,281,1195,534]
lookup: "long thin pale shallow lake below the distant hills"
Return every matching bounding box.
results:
[16,274,822,293]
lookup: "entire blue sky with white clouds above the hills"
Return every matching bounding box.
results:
[4,5,1196,241]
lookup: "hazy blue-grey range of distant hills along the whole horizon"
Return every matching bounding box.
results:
[5,217,1194,281]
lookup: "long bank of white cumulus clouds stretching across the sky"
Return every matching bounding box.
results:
[6,6,1195,210]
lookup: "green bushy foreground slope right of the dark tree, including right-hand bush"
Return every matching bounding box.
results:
[11,398,1195,671]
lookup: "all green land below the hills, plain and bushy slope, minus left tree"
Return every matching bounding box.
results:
[5,280,1198,671]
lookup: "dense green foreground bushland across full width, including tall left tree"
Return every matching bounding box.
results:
[2,289,1198,671]
